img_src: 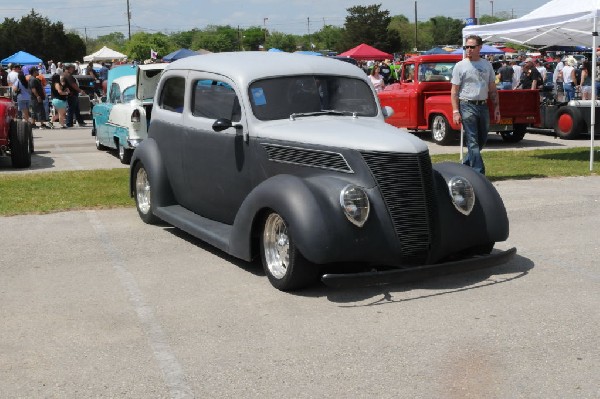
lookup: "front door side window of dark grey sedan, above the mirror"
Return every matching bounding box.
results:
[192,79,241,122]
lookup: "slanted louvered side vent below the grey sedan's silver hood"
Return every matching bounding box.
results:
[262,144,353,173]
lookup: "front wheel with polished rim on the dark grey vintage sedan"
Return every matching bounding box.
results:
[260,212,318,291]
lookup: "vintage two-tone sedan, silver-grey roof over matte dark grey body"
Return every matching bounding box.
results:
[130,52,515,290]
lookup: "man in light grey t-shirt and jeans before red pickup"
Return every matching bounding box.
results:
[450,35,500,174]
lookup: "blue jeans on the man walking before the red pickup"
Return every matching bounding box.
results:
[460,101,490,175]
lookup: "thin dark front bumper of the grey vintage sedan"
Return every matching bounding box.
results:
[321,247,517,288]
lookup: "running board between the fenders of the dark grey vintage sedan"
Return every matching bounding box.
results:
[154,205,233,253]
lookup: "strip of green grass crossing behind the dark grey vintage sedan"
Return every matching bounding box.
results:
[0,148,600,216]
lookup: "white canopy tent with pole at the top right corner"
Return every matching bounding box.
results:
[463,0,600,171]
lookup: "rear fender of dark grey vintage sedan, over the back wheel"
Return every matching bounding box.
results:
[129,139,175,208]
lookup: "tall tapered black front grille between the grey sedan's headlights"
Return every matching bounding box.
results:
[361,151,435,263]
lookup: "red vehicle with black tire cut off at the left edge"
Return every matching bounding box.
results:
[0,87,33,168]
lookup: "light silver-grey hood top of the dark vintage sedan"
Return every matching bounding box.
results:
[250,116,427,153]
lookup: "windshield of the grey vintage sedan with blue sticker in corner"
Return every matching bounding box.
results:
[249,75,378,121]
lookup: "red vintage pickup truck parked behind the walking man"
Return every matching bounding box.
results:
[378,54,540,145]
